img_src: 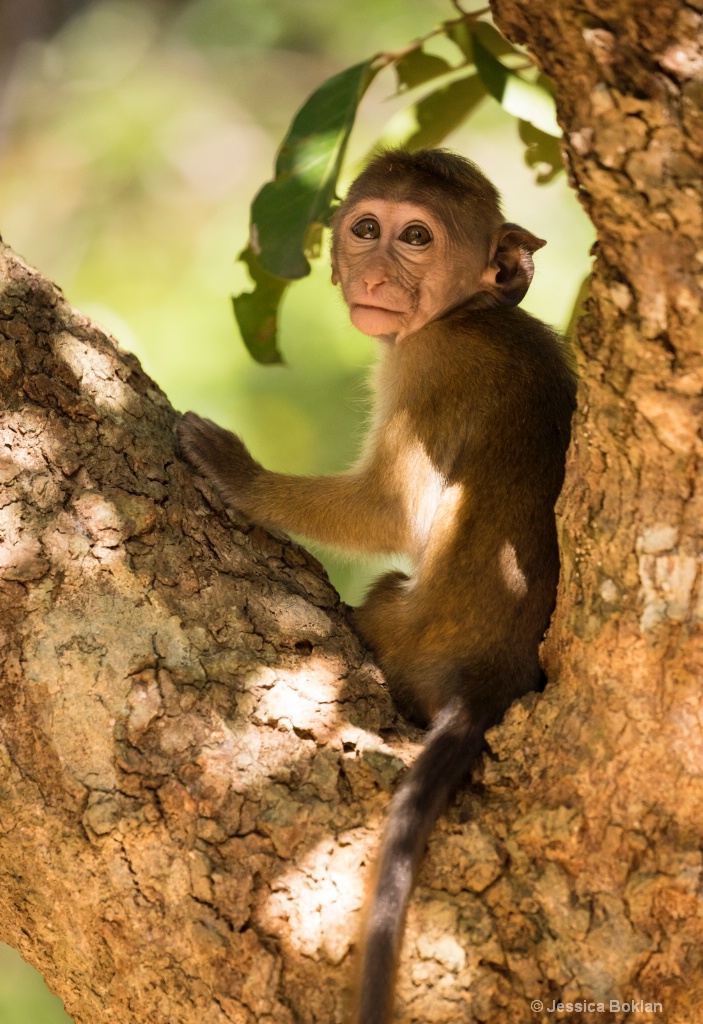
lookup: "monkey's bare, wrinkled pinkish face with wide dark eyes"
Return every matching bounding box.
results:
[332,199,486,342]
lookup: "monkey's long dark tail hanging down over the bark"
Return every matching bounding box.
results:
[356,698,486,1024]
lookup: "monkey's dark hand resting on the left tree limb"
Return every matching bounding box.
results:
[176,413,262,512]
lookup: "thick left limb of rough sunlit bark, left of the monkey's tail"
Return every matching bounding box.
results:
[0,243,410,1024]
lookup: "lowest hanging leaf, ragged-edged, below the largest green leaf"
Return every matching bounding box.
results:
[232,246,291,364]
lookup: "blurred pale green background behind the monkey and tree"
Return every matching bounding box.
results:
[0,0,592,1024]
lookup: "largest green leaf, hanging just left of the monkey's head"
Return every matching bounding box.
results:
[251,57,379,280]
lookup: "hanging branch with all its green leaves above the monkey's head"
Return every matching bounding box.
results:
[233,4,562,364]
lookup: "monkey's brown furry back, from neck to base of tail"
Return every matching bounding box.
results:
[374,309,575,719]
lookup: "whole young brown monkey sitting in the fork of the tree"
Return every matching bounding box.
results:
[178,150,575,1024]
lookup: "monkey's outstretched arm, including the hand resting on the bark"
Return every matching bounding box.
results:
[178,413,408,553]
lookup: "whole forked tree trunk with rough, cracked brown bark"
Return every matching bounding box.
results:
[0,0,703,1024]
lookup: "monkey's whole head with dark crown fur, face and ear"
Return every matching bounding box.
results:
[332,150,545,341]
